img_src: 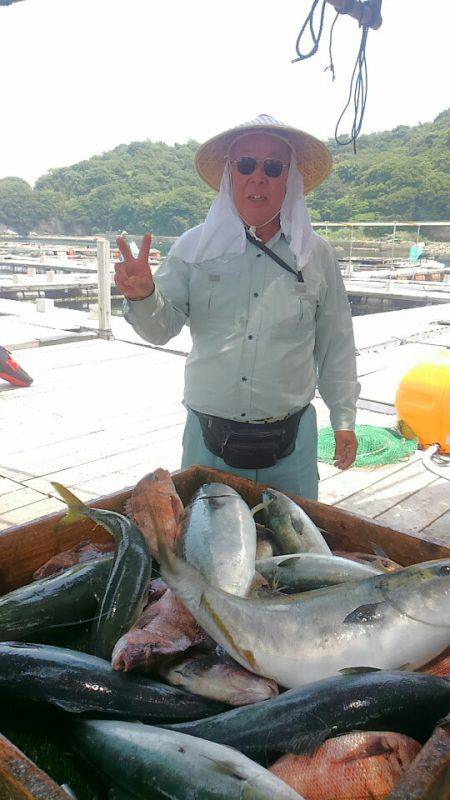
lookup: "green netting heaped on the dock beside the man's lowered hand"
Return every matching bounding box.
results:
[317,425,418,467]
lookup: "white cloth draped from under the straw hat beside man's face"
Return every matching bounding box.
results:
[169,153,314,269]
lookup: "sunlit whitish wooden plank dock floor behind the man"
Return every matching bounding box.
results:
[0,300,450,545]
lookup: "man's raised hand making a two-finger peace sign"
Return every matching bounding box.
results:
[114,233,155,300]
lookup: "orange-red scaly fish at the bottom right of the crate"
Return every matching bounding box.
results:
[269,731,421,800]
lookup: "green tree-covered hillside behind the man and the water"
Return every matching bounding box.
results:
[0,109,450,235]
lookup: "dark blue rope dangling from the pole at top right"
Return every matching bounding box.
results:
[292,0,382,153]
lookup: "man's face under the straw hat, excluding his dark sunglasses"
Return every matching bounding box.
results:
[230,133,291,227]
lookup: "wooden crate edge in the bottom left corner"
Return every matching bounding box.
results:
[0,734,68,800]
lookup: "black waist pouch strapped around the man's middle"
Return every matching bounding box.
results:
[191,406,308,469]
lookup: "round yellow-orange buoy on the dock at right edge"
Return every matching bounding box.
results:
[395,350,450,453]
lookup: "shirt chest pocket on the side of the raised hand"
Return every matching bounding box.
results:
[189,263,239,330]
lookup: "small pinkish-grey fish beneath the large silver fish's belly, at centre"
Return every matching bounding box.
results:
[160,646,278,706]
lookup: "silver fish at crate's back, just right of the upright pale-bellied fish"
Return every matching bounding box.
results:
[256,489,331,555]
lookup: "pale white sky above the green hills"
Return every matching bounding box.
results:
[0,0,450,183]
